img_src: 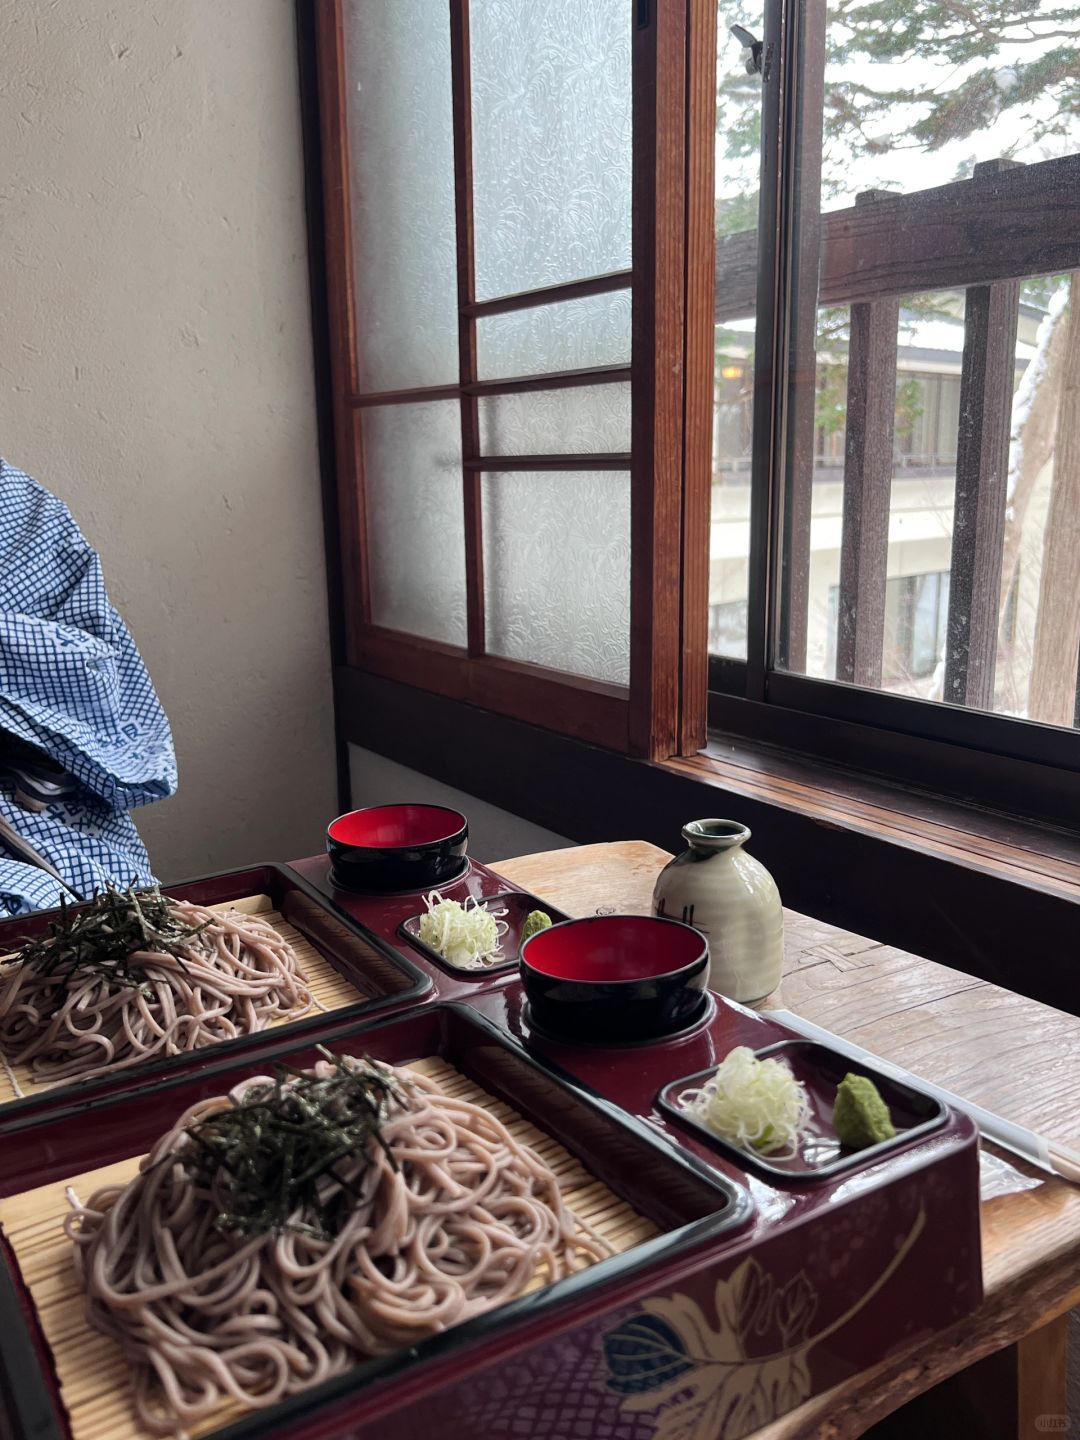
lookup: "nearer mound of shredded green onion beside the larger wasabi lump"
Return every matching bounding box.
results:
[678,1045,811,1159]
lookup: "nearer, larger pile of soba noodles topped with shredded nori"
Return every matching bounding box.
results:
[66,1057,609,1434]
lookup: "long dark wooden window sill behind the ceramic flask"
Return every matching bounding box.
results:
[337,668,1080,1014]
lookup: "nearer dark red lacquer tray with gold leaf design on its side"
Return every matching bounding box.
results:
[0,984,982,1440]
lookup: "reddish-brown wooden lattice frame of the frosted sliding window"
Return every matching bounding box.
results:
[315,0,714,759]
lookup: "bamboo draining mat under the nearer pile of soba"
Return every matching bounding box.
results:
[0,1057,658,1440]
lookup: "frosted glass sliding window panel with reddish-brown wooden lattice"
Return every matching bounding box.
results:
[317,0,696,755]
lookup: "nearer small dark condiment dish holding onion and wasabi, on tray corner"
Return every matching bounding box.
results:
[657,1040,948,1184]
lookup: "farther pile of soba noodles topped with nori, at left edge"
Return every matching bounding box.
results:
[0,891,314,1083]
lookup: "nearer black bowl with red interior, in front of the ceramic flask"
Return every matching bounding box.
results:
[521,914,708,1043]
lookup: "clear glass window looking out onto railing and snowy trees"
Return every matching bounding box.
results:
[710,0,1080,768]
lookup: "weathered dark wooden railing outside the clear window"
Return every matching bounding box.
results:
[716,156,1080,720]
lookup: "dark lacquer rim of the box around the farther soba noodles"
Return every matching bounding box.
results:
[0,864,433,1133]
